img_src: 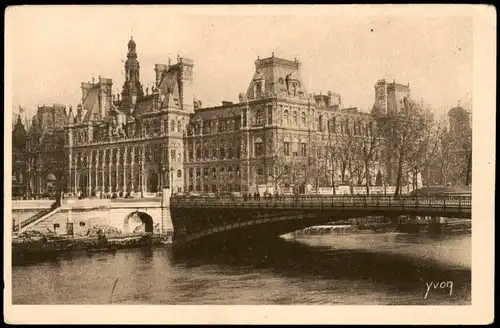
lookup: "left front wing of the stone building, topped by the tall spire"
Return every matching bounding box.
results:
[65,39,198,195]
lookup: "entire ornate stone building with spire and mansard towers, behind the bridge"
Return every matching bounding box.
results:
[14,39,409,197]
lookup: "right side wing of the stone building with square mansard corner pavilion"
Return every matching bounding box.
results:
[184,54,380,192]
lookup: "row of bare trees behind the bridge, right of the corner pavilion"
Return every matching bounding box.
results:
[268,101,472,195]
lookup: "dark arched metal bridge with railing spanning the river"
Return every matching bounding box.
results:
[170,195,471,246]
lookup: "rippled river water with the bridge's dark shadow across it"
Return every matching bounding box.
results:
[12,233,471,305]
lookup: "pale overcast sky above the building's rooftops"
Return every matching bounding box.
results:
[6,6,473,121]
